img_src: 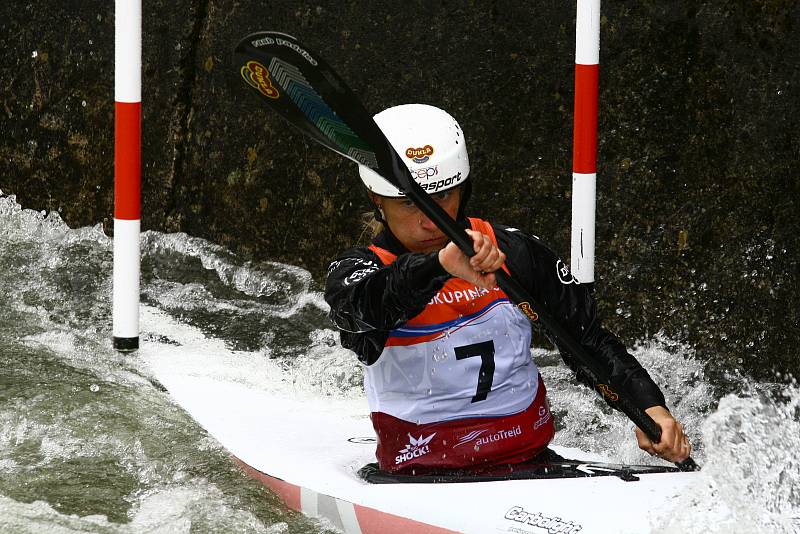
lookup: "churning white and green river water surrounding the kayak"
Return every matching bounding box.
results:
[0,196,800,533]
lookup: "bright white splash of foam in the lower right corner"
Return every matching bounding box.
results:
[661,384,800,534]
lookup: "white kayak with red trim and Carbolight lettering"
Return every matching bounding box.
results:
[140,309,698,534]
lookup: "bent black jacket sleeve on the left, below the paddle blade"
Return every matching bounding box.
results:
[325,248,450,365]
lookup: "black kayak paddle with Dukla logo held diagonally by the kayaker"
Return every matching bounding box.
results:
[234,32,698,471]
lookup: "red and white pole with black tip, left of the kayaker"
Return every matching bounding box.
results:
[113,0,142,351]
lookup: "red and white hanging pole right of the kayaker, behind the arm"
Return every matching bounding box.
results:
[570,0,600,284]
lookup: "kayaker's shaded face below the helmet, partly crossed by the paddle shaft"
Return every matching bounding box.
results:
[372,187,461,252]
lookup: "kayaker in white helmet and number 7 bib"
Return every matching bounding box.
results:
[325,104,691,473]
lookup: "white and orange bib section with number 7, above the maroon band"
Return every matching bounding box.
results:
[364,292,539,424]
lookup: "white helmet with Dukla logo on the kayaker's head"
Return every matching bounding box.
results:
[358,104,469,197]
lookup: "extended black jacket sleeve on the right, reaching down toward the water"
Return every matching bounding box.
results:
[496,227,666,409]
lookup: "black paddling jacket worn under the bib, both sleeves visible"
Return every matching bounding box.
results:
[325,220,666,409]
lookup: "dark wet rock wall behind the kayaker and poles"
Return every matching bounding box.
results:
[0,0,800,377]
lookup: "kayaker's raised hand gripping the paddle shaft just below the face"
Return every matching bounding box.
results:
[439,230,506,289]
